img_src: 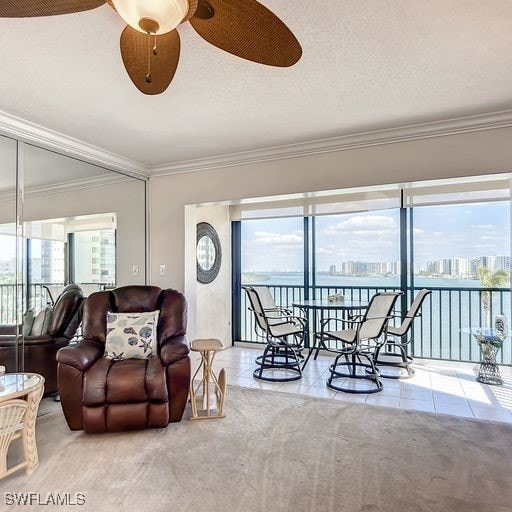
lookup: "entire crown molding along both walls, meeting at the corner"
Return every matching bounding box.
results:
[0,110,512,180]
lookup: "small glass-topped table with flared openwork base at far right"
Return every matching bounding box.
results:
[460,327,511,386]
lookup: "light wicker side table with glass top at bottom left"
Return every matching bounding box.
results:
[0,373,44,478]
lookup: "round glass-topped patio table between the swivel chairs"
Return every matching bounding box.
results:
[292,299,368,368]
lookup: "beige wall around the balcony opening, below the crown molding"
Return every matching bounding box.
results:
[149,128,512,342]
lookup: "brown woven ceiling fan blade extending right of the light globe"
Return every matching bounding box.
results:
[190,0,302,67]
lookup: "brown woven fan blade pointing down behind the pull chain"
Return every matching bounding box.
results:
[121,26,181,95]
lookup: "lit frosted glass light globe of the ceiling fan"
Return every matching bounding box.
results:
[112,0,189,35]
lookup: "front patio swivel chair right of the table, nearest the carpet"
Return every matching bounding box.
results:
[321,292,402,393]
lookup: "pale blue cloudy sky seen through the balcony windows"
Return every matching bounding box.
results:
[242,201,510,272]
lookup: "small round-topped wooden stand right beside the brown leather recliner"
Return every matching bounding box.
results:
[190,339,227,420]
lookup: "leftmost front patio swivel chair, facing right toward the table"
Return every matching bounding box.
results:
[244,286,306,382]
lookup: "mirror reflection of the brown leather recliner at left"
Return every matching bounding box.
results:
[0,284,84,396]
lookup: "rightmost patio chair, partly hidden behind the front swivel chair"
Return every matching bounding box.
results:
[375,288,432,379]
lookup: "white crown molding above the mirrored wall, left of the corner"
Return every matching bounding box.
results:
[0,111,147,179]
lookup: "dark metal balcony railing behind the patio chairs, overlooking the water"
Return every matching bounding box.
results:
[241,283,512,364]
